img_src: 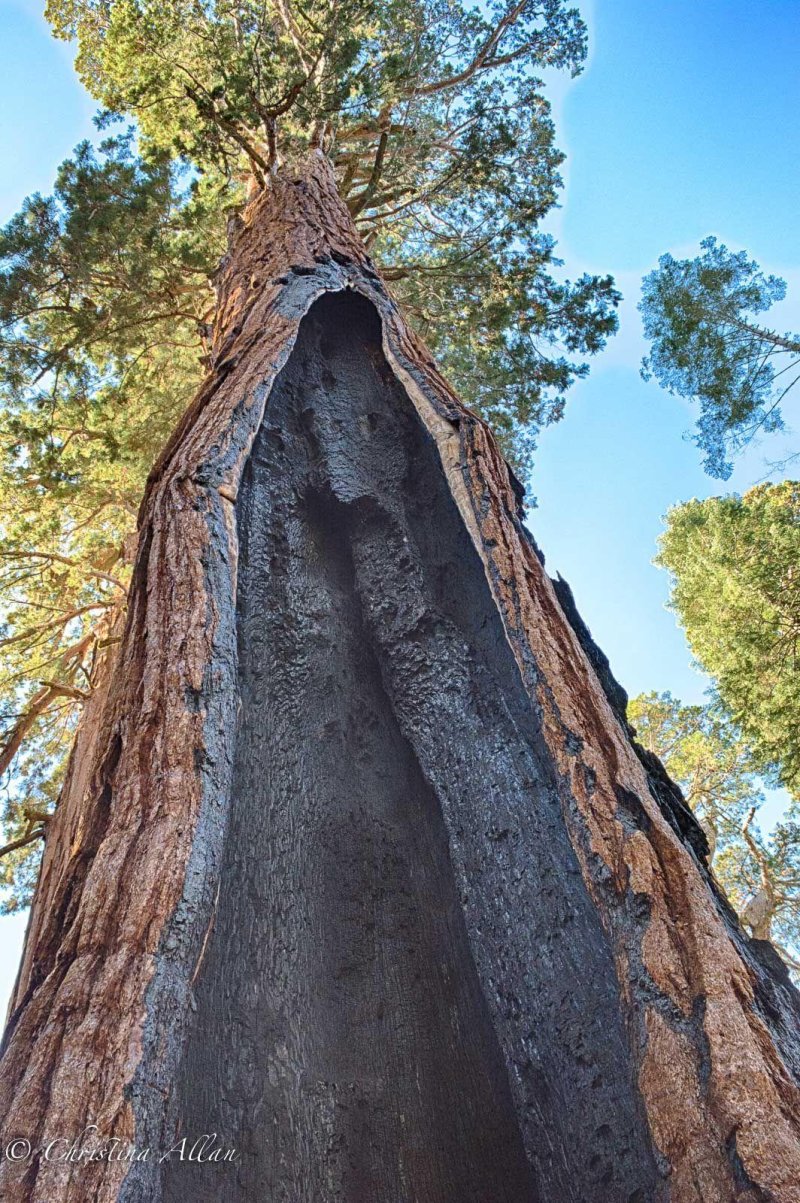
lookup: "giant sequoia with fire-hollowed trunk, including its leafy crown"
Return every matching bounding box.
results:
[0,0,800,1203]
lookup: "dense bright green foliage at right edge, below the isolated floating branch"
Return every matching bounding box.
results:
[657,481,800,798]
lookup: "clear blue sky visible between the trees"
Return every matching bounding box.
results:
[0,0,800,1011]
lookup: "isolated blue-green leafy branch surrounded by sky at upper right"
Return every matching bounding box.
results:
[639,238,800,480]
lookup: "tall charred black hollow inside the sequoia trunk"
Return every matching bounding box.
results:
[162,292,659,1203]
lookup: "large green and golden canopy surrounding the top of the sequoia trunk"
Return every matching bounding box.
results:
[0,0,618,906]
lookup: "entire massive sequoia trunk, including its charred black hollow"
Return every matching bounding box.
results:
[0,153,800,1203]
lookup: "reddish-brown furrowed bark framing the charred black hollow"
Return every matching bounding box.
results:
[0,153,800,1203]
